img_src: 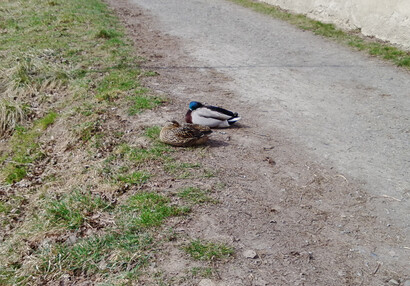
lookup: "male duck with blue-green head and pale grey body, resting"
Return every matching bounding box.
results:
[185,101,241,127]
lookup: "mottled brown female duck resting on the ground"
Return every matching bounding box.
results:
[159,120,212,147]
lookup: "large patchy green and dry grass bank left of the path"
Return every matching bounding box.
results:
[0,0,231,285]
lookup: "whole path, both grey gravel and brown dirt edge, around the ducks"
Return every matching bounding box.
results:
[110,0,410,285]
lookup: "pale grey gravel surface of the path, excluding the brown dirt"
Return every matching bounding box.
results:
[134,0,410,228]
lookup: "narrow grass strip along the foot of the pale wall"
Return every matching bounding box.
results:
[230,0,410,69]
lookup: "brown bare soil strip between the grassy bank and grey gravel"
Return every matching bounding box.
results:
[108,0,410,286]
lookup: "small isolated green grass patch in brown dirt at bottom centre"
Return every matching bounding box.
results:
[184,240,234,261]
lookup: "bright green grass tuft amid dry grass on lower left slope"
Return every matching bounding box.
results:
[45,190,113,229]
